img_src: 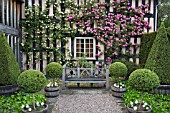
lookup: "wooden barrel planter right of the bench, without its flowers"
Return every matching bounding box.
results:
[111,86,126,97]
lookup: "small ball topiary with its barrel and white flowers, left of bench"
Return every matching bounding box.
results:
[44,62,62,97]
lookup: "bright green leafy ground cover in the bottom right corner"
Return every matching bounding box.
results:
[123,86,170,113]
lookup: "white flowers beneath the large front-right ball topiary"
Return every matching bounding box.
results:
[128,100,152,111]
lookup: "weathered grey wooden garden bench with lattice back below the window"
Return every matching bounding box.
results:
[62,65,109,89]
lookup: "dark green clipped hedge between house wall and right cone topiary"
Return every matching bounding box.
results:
[139,32,157,67]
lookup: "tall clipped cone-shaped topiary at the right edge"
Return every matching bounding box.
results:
[145,23,170,84]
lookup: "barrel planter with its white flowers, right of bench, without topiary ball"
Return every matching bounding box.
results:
[111,83,126,97]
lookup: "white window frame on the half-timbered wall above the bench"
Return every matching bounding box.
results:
[74,37,96,60]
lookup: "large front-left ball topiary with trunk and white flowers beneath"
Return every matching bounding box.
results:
[17,70,48,113]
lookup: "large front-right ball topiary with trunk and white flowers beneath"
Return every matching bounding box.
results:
[126,69,160,113]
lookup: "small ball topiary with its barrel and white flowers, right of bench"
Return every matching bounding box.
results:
[109,62,128,97]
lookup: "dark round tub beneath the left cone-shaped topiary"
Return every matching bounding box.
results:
[0,85,19,96]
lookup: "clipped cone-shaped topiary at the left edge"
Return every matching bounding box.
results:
[0,33,20,85]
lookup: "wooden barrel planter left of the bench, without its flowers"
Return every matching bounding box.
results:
[44,87,60,98]
